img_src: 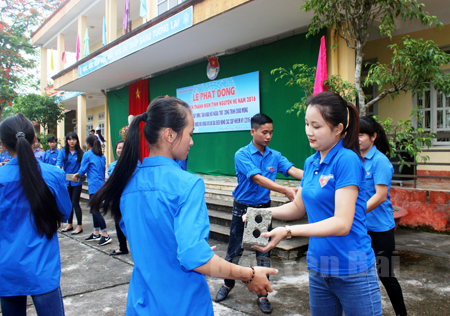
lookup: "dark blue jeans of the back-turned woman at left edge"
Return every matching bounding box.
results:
[0,286,64,316]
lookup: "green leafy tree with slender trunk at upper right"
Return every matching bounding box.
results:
[301,0,449,115]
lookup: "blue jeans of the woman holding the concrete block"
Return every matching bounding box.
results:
[309,265,383,316]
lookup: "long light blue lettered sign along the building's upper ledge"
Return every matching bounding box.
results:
[78,7,192,78]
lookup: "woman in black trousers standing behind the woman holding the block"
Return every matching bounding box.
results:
[359,116,406,316]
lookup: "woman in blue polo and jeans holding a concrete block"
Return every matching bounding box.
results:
[254,92,382,316]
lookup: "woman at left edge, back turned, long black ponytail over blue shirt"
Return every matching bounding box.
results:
[0,114,72,316]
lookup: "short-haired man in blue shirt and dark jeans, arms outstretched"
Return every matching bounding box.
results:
[216,113,303,313]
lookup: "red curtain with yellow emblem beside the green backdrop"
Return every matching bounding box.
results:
[128,79,150,161]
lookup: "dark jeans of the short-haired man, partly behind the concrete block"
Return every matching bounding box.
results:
[225,201,272,288]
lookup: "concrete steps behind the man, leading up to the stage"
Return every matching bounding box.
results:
[81,176,309,259]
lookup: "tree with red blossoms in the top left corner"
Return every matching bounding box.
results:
[0,0,62,120]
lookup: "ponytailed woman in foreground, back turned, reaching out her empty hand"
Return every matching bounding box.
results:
[91,97,277,316]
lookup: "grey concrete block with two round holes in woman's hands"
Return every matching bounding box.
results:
[242,207,272,249]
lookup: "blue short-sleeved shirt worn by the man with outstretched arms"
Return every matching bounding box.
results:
[233,141,294,205]
